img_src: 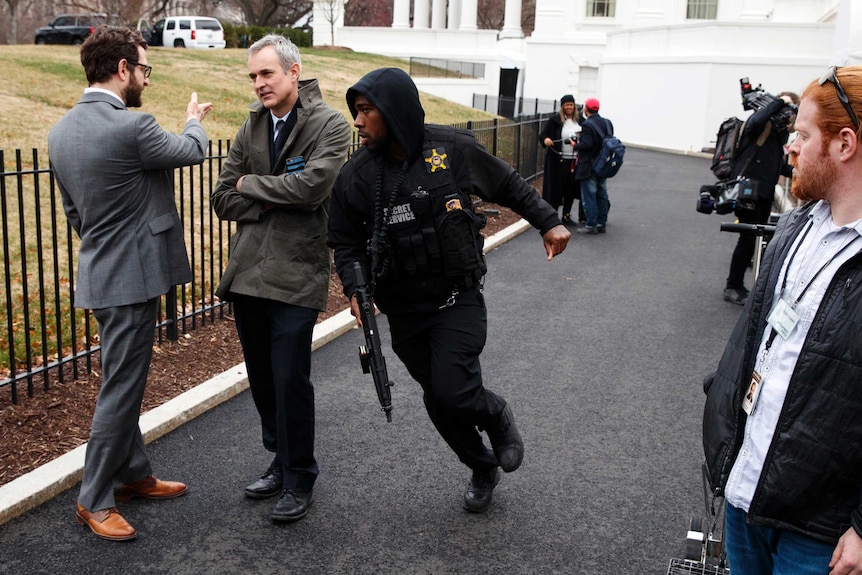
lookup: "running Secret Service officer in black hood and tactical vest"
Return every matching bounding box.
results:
[329,68,571,512]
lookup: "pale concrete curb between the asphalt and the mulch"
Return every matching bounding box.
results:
[0,216,531,525]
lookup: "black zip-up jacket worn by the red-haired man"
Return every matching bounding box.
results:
[703,203,862,544]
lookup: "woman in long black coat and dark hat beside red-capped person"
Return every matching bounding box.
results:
[539,94,585,223]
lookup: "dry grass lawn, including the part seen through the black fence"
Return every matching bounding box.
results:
[0,45,493,380]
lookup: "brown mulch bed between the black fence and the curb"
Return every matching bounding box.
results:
[0,204,519,485]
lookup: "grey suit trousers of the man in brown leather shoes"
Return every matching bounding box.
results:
[78,298,159,511]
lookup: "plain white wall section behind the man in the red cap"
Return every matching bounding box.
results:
[600,22,834,151]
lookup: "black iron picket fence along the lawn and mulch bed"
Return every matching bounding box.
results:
[0,116,543,403]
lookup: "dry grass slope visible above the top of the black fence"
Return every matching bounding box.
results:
[0,45,492,152]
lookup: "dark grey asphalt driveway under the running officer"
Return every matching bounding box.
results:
[0,148,740,575]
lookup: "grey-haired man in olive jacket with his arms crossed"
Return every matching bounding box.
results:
[211,35,350,522]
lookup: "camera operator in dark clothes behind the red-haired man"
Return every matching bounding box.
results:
[724,92,799,305]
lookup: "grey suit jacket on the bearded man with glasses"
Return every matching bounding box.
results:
[48,92,207,309]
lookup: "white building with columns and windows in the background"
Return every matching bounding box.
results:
[314,0,862,151]
